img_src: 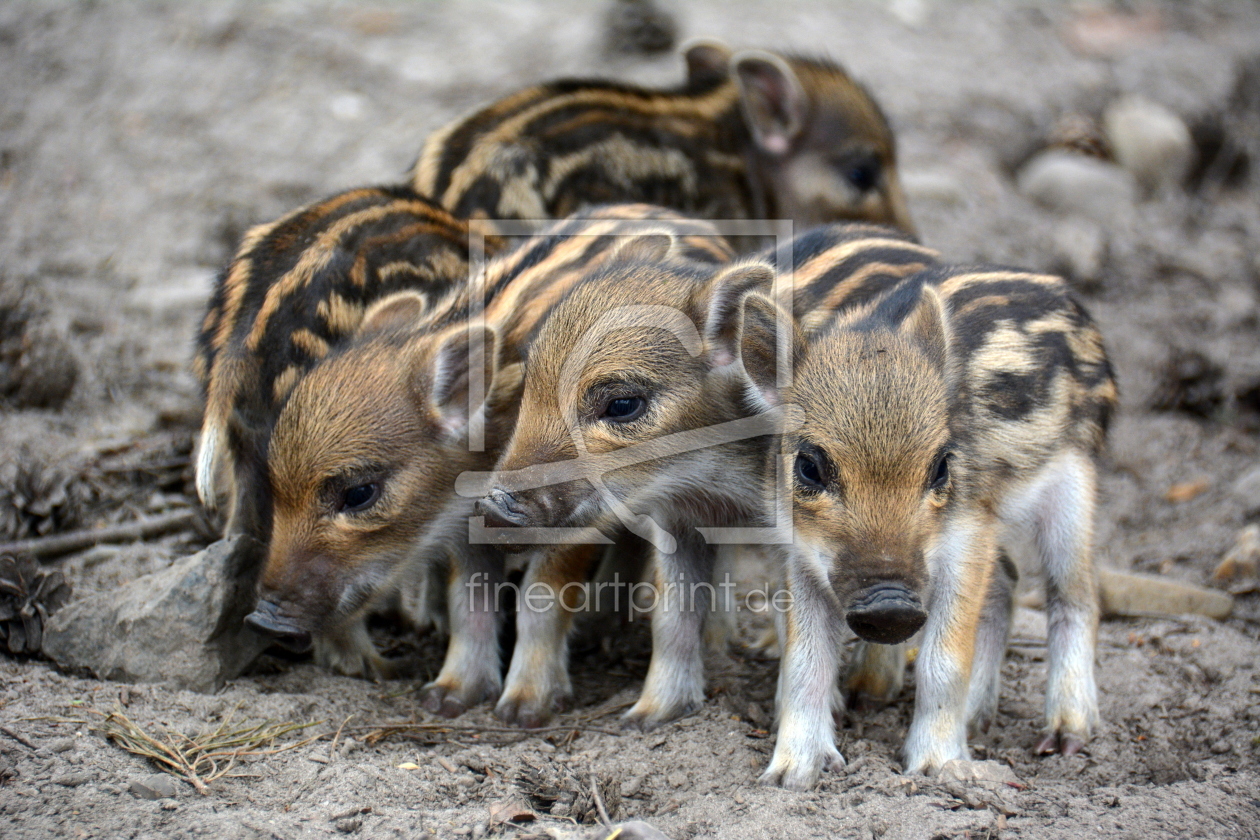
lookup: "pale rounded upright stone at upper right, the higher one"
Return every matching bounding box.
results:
[1103,96,1194,191]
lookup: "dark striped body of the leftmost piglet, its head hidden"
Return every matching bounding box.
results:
[193,188,500,531]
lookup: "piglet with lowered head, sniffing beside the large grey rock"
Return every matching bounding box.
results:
[250,205,731,685]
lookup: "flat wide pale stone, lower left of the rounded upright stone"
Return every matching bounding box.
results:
[1018,149,1138,225]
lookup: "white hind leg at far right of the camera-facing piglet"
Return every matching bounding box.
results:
[1032,452,1099,756]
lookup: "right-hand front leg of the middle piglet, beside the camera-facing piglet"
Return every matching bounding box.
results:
[624,531,714,732]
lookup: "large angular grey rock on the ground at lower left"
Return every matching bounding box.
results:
[43,538,270,691]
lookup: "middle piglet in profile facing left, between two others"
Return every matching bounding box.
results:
[485,224,935,727]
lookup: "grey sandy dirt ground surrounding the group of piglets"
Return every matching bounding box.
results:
[0,0,1260,840]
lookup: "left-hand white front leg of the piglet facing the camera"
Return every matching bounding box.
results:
[759,558,844,791]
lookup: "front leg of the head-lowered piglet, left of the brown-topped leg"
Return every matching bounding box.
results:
[421,545,503,718]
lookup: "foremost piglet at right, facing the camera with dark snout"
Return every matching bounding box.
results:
[762,256,1116,788]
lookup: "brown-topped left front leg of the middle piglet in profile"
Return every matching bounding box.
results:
[494,545,599,728]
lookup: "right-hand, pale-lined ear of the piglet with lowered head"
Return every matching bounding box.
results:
[416,324,499,433]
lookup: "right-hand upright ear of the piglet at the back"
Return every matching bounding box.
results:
[732,50,808,157]
